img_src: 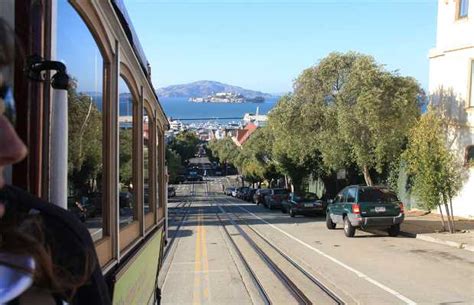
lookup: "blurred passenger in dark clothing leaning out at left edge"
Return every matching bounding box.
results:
[0,18,110,305]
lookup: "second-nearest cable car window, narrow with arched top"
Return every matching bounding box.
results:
[119,78,137,228]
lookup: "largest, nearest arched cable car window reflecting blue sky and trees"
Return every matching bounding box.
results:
[56,1,105,241]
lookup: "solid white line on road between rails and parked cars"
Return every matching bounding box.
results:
[237,206,416,305]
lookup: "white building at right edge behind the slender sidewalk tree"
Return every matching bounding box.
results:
[429,0,474,217]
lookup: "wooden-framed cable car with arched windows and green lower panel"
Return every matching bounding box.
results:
[0,0,169,304]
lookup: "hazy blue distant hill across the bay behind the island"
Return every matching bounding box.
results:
[157,80,272,98]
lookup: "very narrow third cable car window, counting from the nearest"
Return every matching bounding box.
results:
[143,108,153,214]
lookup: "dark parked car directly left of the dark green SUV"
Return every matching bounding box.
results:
[281,193,326,217]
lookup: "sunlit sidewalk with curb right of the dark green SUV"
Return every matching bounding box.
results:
[400,211,474,252]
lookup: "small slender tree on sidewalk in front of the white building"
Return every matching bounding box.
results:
[402,107,462,233]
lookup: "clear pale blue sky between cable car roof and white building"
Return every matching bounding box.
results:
[124,0,437,93]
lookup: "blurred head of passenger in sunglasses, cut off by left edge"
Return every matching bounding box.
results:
[0,19,26,189]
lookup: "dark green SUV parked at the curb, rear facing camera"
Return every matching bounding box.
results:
[326,185,405,237]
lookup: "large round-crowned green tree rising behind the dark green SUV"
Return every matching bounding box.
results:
[291,52,420,185]
